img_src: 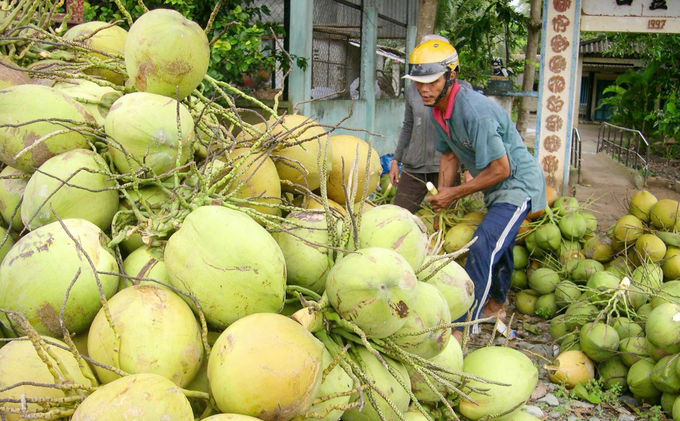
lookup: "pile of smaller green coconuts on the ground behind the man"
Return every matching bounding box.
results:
[512,190,680,420]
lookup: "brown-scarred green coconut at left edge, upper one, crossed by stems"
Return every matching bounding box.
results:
[0,85,96,172]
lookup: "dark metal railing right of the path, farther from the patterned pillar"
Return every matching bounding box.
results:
[596,123,650,184]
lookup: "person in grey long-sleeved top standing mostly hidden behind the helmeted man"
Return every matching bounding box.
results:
[389,35,472,213]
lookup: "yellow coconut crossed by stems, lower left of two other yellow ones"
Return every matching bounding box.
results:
[224,148,281,216]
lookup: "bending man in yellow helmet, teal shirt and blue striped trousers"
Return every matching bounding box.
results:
[404,40,546,341]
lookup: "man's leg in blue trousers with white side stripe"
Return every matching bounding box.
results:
[465,200,529,333]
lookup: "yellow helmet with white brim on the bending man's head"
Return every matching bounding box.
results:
[404,39,458,83]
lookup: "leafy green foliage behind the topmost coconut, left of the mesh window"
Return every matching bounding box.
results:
[84,0,306,84]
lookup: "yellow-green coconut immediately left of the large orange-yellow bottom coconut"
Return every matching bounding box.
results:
[87,285,203,387]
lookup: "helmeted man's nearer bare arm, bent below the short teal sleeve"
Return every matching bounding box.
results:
[427,154,510,212]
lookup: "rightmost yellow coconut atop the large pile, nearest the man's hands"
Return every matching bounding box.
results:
[327,135,382,205]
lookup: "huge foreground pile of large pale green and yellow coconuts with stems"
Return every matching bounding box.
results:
[0,1,538,421]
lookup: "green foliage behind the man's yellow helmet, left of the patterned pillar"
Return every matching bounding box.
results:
[435,0,528,86]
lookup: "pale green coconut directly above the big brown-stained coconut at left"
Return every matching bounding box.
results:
[21,149,118,231]
